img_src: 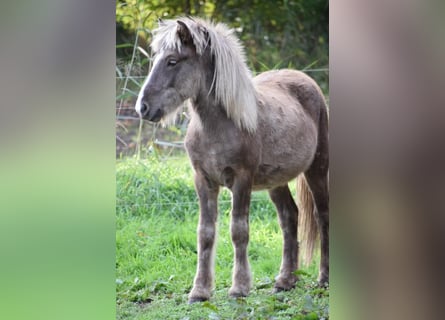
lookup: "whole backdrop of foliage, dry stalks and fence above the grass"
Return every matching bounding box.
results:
[116,0,329,158]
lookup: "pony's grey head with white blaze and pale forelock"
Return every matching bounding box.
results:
[135,19,209,122]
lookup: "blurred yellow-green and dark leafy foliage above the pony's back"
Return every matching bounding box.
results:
[116,0,329,92]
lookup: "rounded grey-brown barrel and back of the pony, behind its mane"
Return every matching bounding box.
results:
[253,69,325,189]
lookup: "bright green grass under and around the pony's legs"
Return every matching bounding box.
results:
[116,156,329,320]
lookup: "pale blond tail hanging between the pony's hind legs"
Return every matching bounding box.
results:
[297,174,318,265]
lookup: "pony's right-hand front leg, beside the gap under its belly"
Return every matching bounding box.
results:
[229,175,252,297]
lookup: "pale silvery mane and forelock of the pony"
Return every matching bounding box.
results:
[151,18,258,133]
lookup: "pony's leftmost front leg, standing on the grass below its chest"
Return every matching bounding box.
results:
[189,172,219,303]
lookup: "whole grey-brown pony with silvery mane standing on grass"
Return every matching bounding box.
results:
[135,18,329,303]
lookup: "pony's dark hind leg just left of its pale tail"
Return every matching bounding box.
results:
[269,185,298,291]
